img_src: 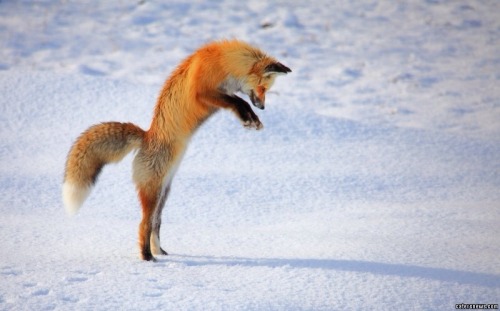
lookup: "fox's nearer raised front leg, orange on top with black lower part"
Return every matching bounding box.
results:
[198,93,264,130]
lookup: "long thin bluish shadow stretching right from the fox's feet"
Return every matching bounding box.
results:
[165,255,500,288]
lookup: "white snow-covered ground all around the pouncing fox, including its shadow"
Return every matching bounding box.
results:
[0,0,500,310]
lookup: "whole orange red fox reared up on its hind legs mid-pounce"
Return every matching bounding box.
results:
[62,39,291,261]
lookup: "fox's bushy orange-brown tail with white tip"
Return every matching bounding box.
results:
[62,122,145,214]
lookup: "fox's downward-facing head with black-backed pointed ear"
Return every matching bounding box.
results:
[242,57,292,109]
